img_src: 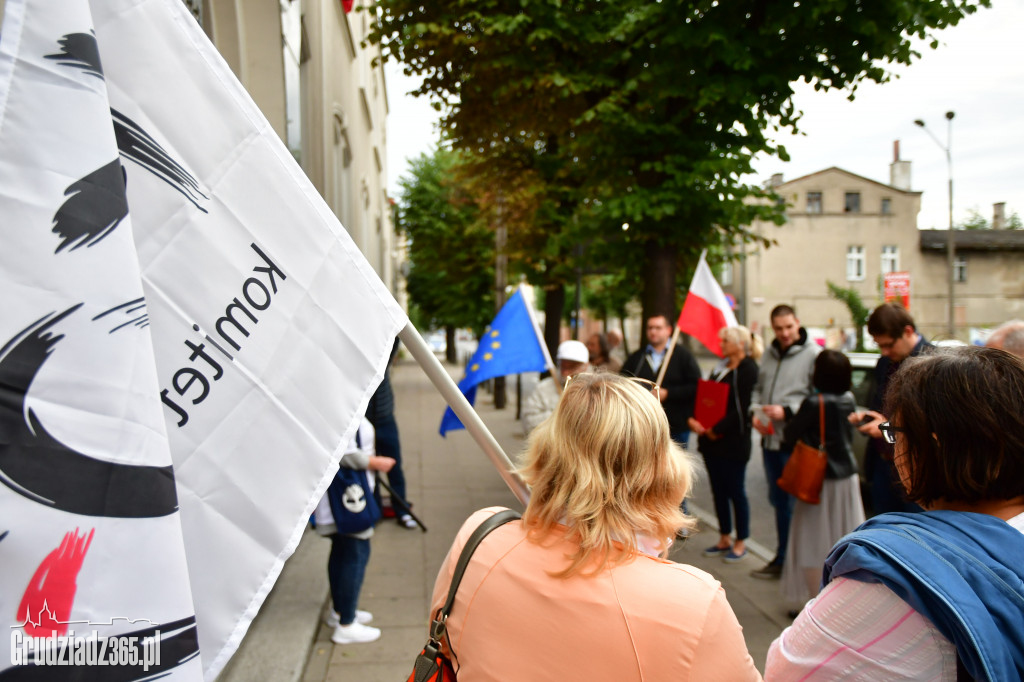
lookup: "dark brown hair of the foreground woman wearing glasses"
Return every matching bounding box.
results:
[886,346,1024,505]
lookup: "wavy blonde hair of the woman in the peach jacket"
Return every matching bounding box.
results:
[519,373,696,578]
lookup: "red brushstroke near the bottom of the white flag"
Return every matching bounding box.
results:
[17,528,96,637]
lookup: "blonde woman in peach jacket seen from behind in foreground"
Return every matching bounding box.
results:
[431,373,761,682]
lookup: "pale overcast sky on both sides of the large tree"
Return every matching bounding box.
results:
[386,0,1024,228]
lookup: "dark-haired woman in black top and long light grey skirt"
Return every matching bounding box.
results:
[781,350,864,615]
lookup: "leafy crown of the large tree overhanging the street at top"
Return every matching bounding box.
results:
[372,0,989,329]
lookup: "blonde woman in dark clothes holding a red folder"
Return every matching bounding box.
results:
[689,326,763,563]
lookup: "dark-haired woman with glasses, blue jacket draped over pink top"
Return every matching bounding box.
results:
[765,347,1024,681]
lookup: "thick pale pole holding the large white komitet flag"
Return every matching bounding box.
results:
[398,323,529,506]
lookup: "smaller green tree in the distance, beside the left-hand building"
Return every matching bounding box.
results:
[398,144,495,361]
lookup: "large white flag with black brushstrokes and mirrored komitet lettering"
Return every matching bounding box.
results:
[0,0,407,680]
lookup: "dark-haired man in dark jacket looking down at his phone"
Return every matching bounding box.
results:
[855,303,935,514]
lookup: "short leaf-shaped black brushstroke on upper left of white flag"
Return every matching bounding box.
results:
[52,159,128,253]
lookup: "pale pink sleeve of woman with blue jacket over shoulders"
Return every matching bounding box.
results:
[765,578,956,682]
